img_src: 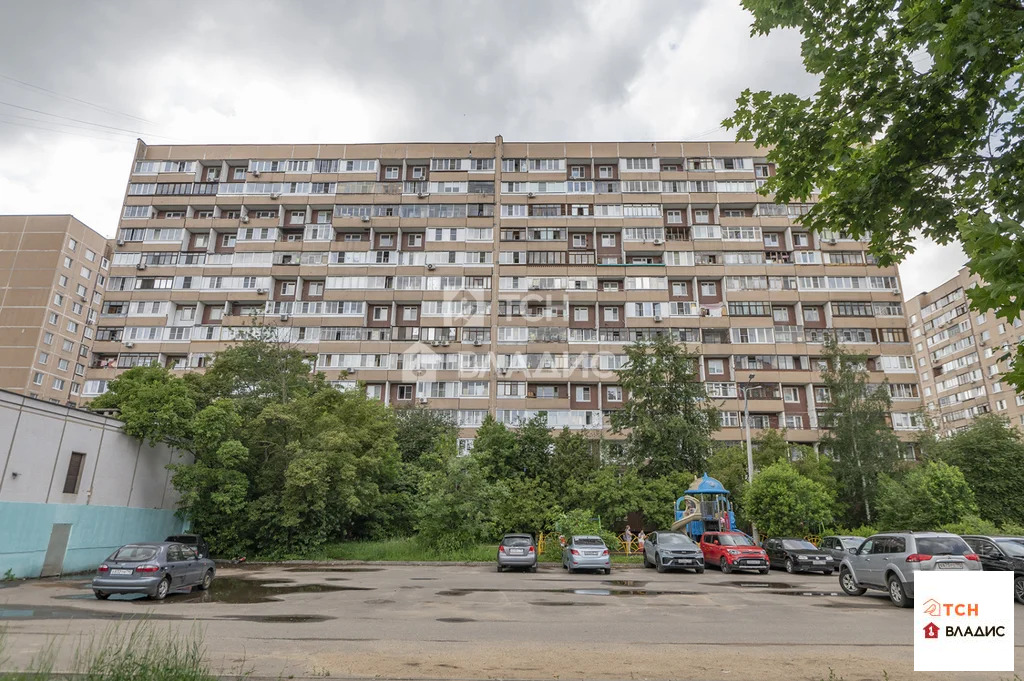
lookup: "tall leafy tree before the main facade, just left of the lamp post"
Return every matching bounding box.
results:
[611,336,720,478]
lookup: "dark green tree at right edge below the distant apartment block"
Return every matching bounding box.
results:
[925,415,1024,524]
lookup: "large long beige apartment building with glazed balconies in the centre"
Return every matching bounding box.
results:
[86,136,921,454]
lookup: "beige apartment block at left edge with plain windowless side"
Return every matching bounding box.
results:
[0,215,111,406]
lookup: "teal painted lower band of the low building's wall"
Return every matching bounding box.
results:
[0,502,187,578]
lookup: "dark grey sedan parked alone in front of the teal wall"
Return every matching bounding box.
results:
[92,542,216,600]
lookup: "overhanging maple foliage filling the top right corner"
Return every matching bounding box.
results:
[725,0,1024,388]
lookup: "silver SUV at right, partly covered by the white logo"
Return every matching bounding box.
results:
[839,533,981,607]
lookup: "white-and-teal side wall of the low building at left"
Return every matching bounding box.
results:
[0,391,190,577]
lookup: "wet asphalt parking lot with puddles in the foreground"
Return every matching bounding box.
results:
[0,564,1024,681]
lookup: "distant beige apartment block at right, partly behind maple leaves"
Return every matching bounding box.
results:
[907,267,1024,435]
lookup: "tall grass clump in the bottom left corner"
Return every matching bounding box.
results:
[0,622,217,681]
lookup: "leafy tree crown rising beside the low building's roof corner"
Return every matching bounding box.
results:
[89,365,197,448]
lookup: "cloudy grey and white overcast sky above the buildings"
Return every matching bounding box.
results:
[0,0,965,296]
